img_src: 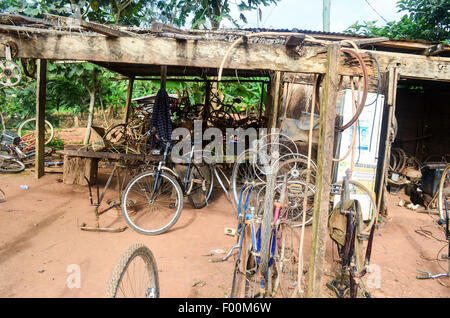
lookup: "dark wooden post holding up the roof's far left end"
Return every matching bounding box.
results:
[34,59,47,179]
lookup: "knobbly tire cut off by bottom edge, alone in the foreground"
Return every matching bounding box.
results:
[105,244,159,298]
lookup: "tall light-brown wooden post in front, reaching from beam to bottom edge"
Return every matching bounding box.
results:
[306,44,340,297]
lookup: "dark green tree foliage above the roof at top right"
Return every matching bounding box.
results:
[345,0,450,44]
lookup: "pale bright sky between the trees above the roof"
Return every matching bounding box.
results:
[221,0,405,32]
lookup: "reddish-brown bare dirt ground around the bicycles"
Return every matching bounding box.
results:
[0,127,450,298]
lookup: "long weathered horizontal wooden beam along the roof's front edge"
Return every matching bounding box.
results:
[0,32,450,81]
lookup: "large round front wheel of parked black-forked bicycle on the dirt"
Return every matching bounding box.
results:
[122,171,183,235]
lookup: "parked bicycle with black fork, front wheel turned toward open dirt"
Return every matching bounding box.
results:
[122,129,213,235]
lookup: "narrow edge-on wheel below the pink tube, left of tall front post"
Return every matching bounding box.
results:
[273,223,303,298]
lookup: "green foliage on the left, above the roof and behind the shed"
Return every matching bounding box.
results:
[0,0,272,128]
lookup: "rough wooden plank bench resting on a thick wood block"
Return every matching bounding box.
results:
[56,150,160,185]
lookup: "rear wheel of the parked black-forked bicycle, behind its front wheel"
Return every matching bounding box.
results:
[188,164,213,209]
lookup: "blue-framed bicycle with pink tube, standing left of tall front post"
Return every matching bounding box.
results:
[231,177,302,298]
